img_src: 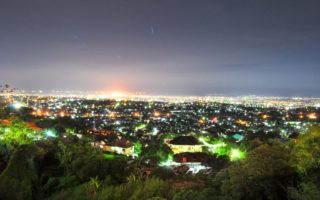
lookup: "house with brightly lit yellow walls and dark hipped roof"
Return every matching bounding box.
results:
[167,136,203,154]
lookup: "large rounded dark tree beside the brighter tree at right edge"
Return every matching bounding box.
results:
[214,144,293,199]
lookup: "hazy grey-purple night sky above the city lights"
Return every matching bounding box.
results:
[0,0,320,96]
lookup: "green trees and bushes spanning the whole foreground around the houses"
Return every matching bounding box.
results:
[0,104,320,200]
